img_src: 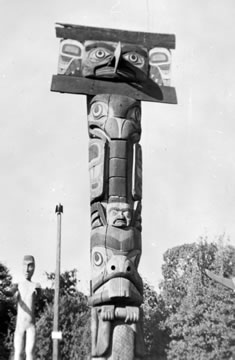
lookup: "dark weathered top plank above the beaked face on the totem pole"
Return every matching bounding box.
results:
[56,23,175,49]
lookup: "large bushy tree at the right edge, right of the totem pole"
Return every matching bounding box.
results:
[161,239,235,360]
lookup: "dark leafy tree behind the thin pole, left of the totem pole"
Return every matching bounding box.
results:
[36,270,90,360]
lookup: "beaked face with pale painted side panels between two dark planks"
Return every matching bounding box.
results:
[58,39,171,86]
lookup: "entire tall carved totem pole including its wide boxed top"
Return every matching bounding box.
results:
[51,24,177,360]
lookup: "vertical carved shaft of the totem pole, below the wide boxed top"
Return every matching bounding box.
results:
[87,95,145,360]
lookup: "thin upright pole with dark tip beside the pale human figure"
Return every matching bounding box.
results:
[52,204,63,360]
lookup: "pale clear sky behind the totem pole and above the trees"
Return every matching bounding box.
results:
[0,0,235,292]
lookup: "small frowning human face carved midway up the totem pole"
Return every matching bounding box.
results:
[107,203,132,228]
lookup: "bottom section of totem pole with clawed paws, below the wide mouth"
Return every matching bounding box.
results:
[92,305,145,360]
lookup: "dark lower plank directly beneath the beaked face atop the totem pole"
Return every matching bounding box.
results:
[51,75,177,104]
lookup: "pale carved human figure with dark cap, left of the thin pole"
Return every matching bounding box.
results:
[1,255,41,360]
